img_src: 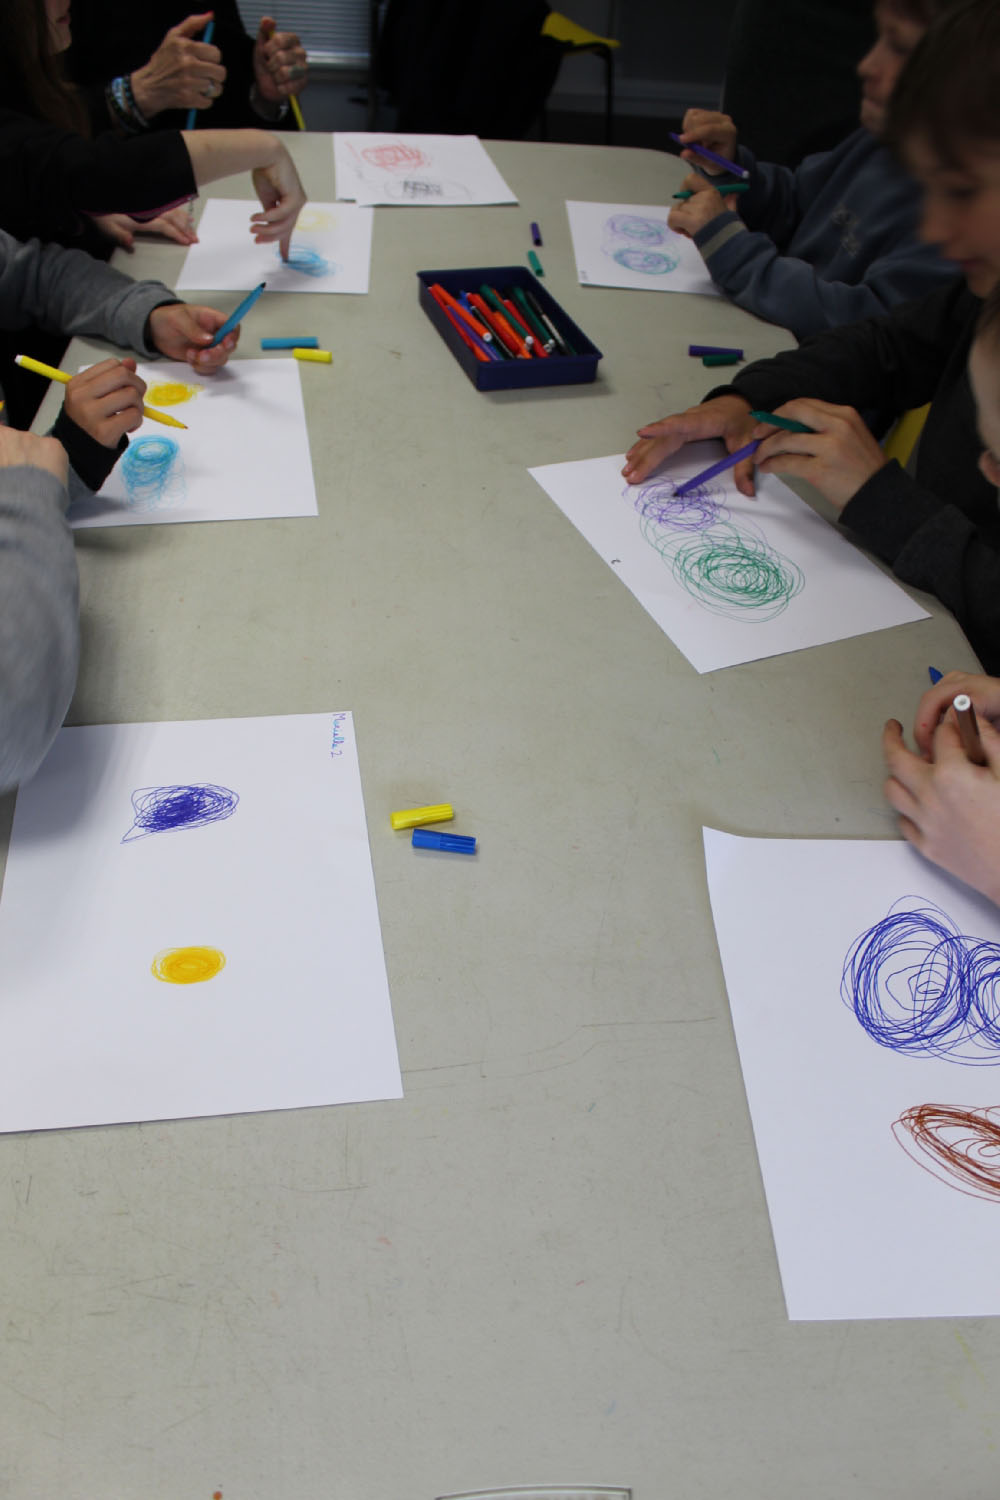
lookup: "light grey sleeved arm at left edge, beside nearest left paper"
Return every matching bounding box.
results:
[0,428,79,791]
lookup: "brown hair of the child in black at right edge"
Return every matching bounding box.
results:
[888,0,1000,168]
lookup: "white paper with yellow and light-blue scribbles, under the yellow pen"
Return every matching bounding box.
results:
[69,359,316,527]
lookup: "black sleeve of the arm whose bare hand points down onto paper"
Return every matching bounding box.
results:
[0,110,196,242]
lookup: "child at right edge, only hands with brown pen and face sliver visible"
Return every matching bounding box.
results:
[882,288,1000,906]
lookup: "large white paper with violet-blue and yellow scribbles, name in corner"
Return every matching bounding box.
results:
[0,713,402,1131]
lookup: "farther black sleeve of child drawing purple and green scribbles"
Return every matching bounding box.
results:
[706,279,978,413]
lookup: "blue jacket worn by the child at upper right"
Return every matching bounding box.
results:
[694,129,955,339]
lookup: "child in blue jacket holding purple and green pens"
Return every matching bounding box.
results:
[669,0,955,339]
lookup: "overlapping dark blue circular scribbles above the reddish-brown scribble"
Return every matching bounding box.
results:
[841,896,1000,1067]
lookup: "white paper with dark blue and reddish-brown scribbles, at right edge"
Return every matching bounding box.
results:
[705,828,1000,1319]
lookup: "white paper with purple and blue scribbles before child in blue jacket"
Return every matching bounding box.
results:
[567,201,721,297]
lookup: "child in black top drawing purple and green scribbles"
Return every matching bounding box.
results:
[622,0,1000,671]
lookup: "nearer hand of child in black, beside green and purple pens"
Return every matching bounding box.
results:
[751,396,889,512]
